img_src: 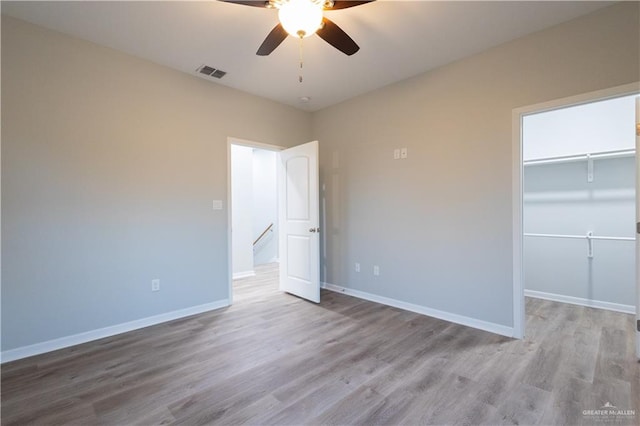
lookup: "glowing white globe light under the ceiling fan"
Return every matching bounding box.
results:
[278,0,324,38]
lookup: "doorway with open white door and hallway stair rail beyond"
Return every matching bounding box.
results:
[227,138,321,304]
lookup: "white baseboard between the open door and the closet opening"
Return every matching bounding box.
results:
[322,282,514,337]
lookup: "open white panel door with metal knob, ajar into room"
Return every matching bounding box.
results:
[278,141,320,303]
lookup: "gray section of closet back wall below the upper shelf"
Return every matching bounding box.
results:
[523,157,636,305]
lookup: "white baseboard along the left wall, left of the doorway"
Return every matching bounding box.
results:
[0,299,229,363]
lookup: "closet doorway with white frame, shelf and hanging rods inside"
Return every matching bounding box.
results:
[513,83,640,338]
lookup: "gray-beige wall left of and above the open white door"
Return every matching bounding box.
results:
[2,16,311,351]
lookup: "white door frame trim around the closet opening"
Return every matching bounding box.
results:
[511,82,640,339]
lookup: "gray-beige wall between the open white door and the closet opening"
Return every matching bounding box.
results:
[313,2,640,326]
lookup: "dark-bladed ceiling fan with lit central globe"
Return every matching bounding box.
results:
[220,0,375,56]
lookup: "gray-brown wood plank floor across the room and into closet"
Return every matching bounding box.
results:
[2,265,640,425]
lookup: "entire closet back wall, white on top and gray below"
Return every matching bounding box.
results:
[523,97,635,312]
